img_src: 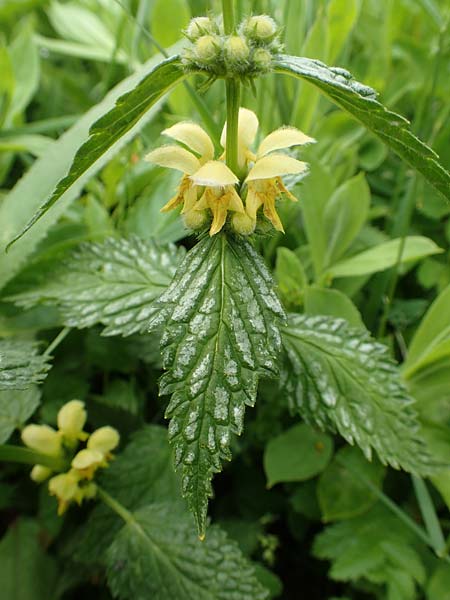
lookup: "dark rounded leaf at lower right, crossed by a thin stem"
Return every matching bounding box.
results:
[317,446,385,522]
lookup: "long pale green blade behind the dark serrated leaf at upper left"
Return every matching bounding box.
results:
[0,47,183,289]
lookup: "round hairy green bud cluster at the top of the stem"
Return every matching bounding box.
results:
[182,15,282,80]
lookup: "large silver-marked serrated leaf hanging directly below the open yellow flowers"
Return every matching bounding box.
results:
[151,234,284,535]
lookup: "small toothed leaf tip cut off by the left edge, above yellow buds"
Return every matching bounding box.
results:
[0,340,50,390]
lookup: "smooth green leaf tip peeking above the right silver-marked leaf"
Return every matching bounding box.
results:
[304,285,364,329]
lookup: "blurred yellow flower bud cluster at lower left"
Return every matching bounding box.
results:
[22,400,120,515]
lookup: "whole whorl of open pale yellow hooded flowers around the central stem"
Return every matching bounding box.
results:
[145,108,315,235]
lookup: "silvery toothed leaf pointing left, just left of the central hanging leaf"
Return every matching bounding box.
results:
[10,237,183,335]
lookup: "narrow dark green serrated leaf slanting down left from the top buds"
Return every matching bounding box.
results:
[7,56,185,248]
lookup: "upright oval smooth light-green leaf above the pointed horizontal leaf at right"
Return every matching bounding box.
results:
[324,173,370,265]
